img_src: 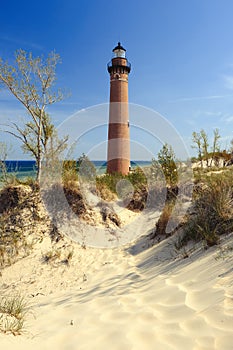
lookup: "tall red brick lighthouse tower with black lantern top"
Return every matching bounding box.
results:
[107,43,131,175]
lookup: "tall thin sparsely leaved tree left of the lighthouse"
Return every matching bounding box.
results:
[0,49,67,181]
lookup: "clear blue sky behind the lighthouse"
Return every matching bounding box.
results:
[0,0,233,159]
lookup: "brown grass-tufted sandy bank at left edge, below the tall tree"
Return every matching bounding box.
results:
[0,185,44,267]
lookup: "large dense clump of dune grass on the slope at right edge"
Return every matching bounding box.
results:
[177,172,233,247]
